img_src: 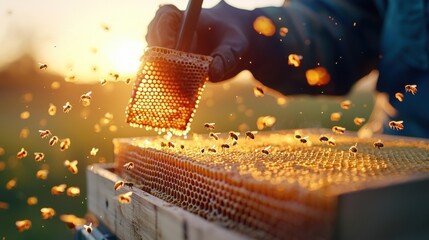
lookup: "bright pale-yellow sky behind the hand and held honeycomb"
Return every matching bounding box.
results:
[0,0,284,82]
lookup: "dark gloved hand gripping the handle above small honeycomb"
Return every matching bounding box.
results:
[146,1,280,82]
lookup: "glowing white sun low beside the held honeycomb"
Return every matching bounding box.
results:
[108,39,143,75]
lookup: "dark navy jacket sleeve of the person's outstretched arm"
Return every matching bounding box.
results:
[249,0,382,95]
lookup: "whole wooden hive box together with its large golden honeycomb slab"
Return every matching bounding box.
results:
[89,130,429,239]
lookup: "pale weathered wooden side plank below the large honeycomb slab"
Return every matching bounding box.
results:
[87,164,249,240]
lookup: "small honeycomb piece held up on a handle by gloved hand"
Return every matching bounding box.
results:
[126,47,212,135]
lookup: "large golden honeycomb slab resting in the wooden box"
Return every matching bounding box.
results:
[114,130,429,239]
